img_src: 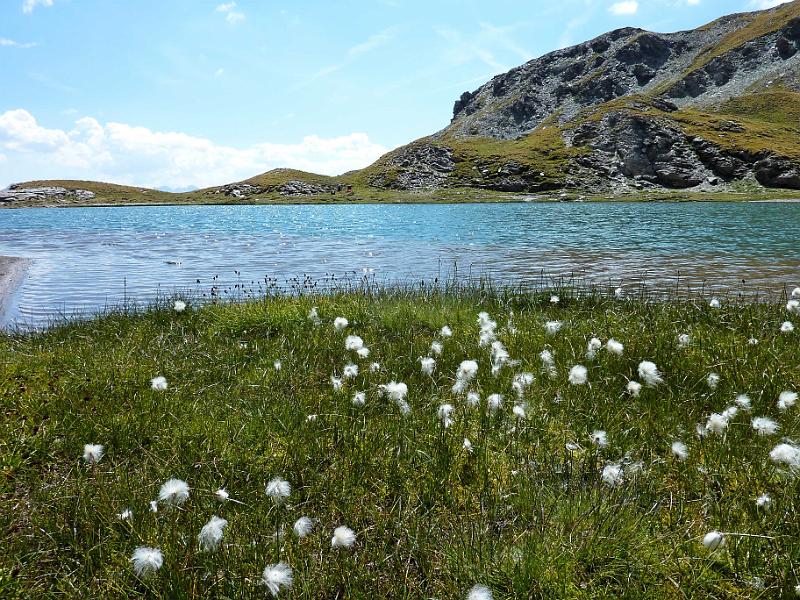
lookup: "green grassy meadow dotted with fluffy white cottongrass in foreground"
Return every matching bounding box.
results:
[0,288,800,600]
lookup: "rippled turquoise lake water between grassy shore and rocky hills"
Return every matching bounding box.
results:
[0,203,800,323]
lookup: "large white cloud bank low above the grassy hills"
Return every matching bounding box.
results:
[0,109,386,188]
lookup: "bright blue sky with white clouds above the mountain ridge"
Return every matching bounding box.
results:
[0,0,786,190]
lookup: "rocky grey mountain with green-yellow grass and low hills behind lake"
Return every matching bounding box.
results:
[0,0,800,204]
